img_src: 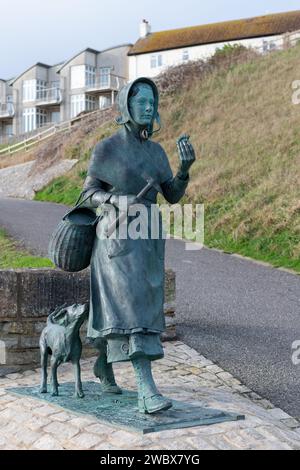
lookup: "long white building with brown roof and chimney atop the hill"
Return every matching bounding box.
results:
[128,11,300,80]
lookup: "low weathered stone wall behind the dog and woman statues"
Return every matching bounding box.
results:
[0,269,176,375]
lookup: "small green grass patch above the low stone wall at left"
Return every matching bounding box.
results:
[0,229,54,269]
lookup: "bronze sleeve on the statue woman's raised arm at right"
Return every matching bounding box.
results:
[160,143,190,204]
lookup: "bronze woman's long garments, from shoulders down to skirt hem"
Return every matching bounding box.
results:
[84,126,188,338]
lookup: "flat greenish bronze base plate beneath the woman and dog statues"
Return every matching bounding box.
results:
[7,382,244,434]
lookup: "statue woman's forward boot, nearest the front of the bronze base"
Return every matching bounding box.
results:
[132,356,172,414]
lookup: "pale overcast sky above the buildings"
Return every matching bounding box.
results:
[0,0,300,79]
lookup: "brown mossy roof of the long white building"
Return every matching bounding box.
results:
[128,10,300,55]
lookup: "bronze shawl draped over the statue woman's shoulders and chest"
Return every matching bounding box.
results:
[88,126,173,198]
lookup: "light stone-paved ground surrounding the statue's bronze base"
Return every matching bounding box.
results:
[0,341,300,450]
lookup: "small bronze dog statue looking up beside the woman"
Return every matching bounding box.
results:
[40,303,89,398]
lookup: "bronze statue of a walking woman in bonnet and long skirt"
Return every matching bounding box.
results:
[84,78,195,413]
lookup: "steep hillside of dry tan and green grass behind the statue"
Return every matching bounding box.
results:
[37,46,300,272]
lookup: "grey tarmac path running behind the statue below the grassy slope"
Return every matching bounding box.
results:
[0,199,300,418]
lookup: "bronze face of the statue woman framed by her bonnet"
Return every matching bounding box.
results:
[129,85,154,126]
